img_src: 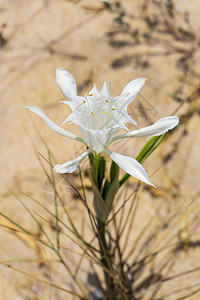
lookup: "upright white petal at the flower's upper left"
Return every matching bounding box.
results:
[56,68,77,100]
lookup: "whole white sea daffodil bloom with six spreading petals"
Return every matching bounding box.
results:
[26,68,179,185]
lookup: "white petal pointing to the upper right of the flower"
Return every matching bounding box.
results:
[121,78,146,104]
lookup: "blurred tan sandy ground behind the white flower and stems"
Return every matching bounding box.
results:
[0,0,200,299]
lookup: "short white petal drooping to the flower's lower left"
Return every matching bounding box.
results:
[54,149,91,174]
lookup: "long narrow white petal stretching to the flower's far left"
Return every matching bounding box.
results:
[25,105,85,144]
